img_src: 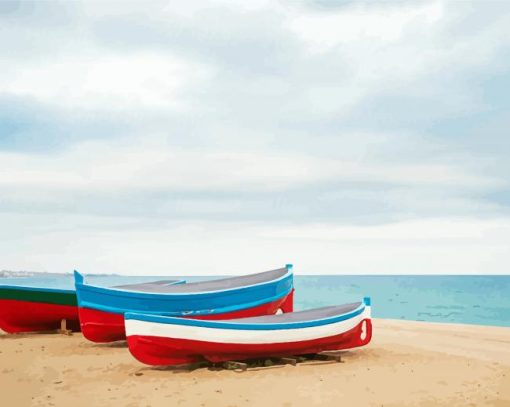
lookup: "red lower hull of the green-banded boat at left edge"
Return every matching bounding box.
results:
[0,299,80,333]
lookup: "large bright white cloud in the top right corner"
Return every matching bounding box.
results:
[283,1,510,118]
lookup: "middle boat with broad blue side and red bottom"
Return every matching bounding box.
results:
[75,264,293,343]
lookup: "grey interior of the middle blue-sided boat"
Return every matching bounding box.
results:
[108,267,287,293]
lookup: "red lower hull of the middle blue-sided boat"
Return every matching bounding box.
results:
[79,290,294,343]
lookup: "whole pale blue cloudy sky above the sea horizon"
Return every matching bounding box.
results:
[0,0,510,275]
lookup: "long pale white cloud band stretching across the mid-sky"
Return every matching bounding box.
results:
[0,137,505,192]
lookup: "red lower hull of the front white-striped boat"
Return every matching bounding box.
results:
[128,319,372,365]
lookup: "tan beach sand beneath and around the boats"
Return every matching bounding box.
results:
[0,320,510,407]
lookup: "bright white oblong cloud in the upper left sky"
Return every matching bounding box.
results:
[0,52,210,111]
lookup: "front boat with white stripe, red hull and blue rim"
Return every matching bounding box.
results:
[125,298,372,365]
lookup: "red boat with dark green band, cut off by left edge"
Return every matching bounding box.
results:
[0,280,183,333]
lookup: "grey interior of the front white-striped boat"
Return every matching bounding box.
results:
[223,302,362,324]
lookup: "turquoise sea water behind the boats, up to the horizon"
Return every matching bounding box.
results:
[0,275,510,327]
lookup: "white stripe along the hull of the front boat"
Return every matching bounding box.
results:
[126,307,370,344]
